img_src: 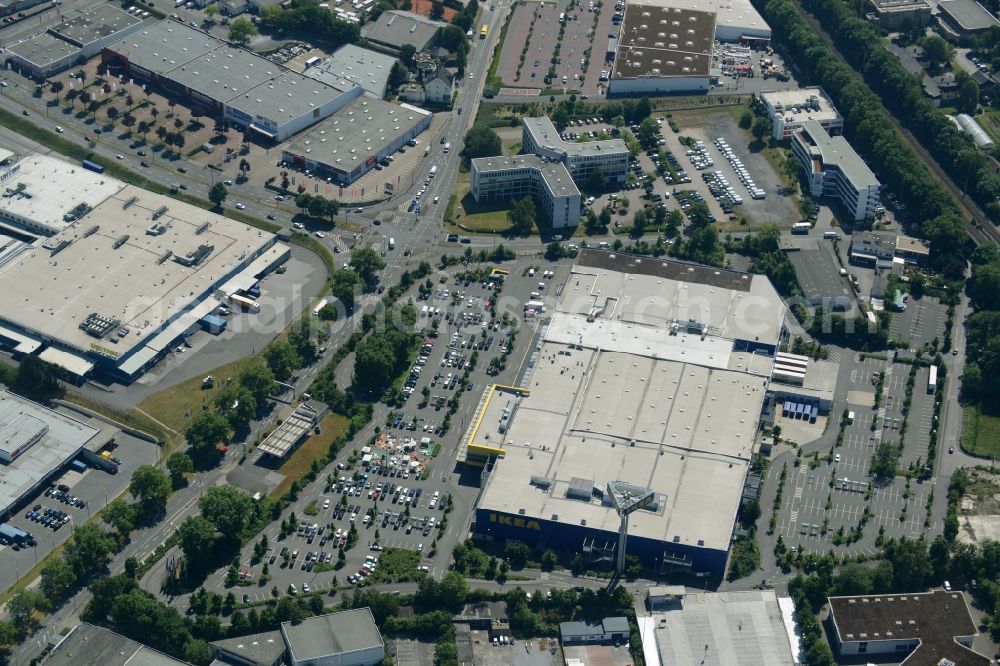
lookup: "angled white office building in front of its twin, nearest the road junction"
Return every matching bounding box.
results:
[472,155,581,229]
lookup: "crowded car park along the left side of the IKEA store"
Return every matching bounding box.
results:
[160,255,568,607]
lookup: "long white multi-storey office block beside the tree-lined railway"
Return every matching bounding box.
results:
[792,120,880,222]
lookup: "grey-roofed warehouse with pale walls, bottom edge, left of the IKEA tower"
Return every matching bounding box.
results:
[281,607,385,666]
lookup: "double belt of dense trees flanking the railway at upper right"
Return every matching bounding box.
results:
[756,0,968,275]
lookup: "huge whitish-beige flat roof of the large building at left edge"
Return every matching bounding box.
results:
[0,157,274,364]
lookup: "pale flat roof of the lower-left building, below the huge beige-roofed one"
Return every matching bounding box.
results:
[0,391,100,510]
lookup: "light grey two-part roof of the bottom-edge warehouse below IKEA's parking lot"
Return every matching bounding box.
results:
[281,607,384,662]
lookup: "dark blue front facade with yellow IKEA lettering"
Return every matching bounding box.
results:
[476,508,729,576]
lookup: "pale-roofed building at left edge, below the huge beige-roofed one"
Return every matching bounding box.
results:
[0,391,101,522]
